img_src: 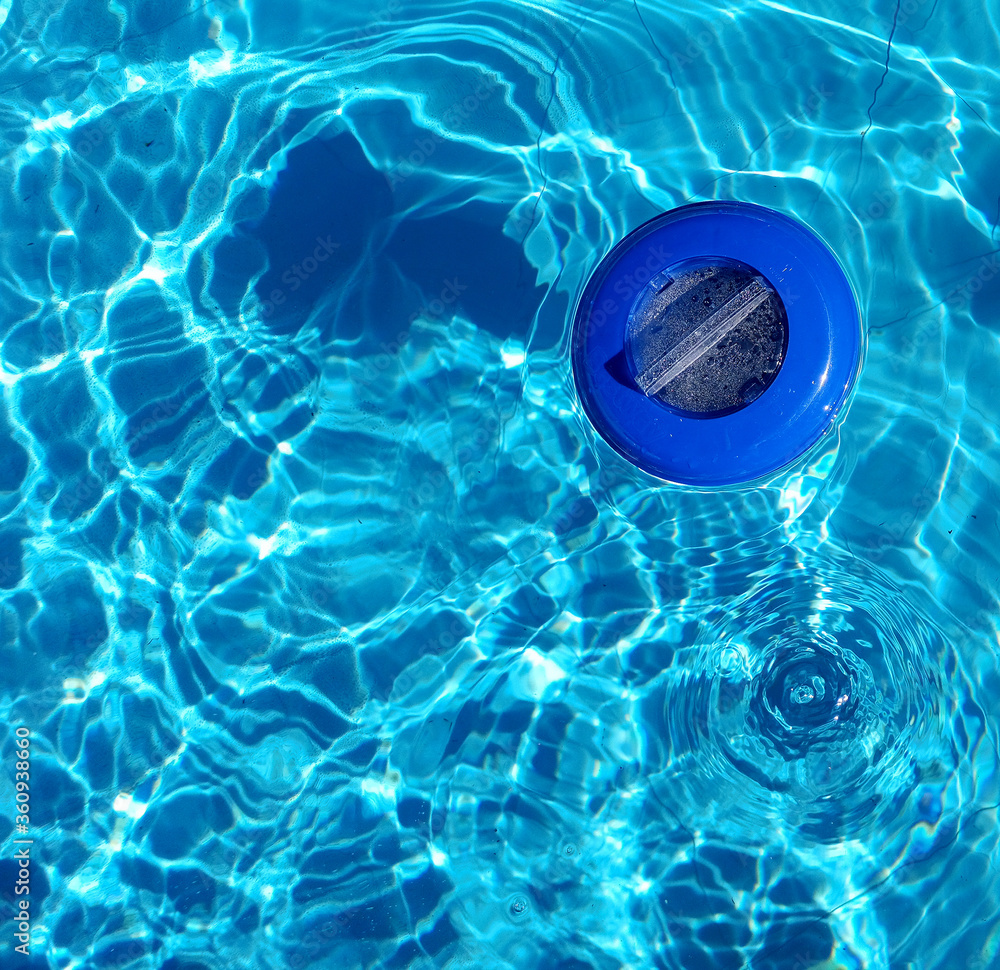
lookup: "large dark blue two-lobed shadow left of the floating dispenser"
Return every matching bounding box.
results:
[213,132,542,355]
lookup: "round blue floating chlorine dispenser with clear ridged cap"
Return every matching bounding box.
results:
[573,202,864,487]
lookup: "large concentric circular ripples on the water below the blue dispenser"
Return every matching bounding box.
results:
[658,560,965,845]
